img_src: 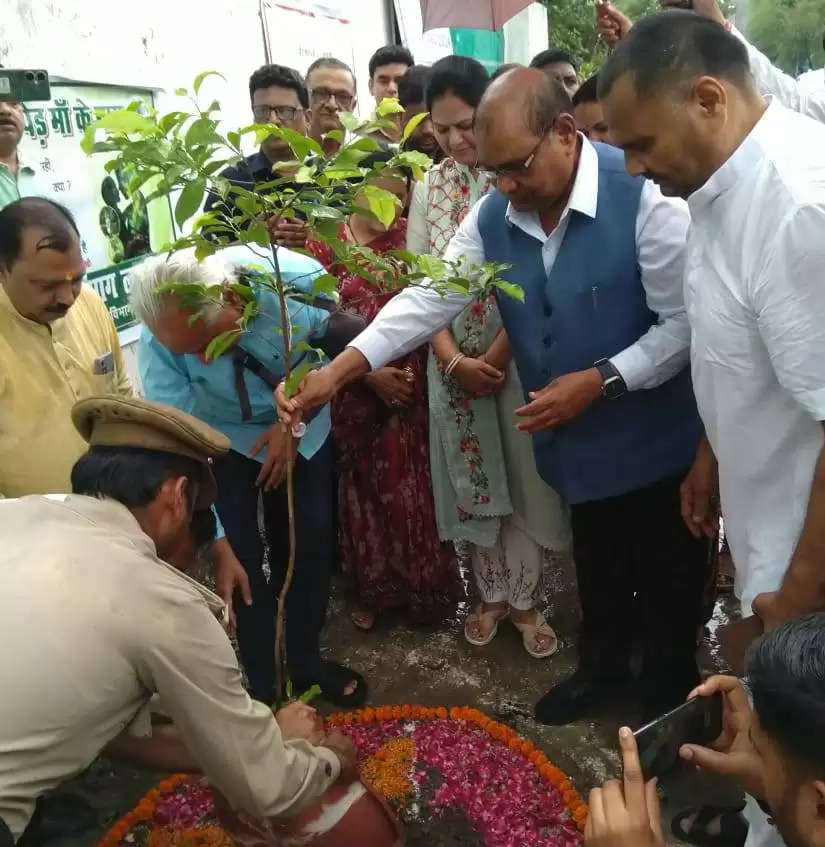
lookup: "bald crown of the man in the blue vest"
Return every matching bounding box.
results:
[475,67,573,138]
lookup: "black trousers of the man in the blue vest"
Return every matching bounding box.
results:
[571,474,708,708]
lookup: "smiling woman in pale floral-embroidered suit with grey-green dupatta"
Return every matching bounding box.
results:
[407,56,569,658]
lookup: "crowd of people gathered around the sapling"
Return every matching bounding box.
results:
[0,0,825,847]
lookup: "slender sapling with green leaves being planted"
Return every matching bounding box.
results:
[81,71,523,699]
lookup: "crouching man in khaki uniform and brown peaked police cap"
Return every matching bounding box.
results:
[0,396,354,843]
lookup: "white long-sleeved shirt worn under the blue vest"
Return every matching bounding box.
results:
[350,136,690,391]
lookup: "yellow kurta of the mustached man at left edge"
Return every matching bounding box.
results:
[0,285,133,497]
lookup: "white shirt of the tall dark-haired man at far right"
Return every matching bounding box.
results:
[685,102,825,614]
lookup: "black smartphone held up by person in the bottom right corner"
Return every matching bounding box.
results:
[633,693,722,779]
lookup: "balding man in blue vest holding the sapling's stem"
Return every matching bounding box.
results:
[278,68,707,724]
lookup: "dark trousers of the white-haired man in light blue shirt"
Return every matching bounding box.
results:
[213,439,335,702]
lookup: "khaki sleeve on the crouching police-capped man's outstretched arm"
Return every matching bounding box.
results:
[139,592,340,818]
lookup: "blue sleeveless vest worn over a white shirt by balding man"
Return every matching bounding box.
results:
[478,144,702,503]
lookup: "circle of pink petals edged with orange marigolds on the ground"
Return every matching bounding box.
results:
[98,705,588,847]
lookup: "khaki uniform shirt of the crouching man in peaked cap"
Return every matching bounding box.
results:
[0,495,339,838]
